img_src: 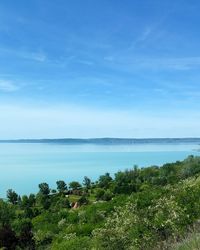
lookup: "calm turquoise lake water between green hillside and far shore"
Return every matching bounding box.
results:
[0,143,200,197]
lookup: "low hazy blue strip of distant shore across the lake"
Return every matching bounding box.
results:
[0,138,200,145]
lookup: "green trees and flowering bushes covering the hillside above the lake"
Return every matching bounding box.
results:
[0,155,200,250]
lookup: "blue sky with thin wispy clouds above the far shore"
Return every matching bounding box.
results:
[0,0,200,139]
